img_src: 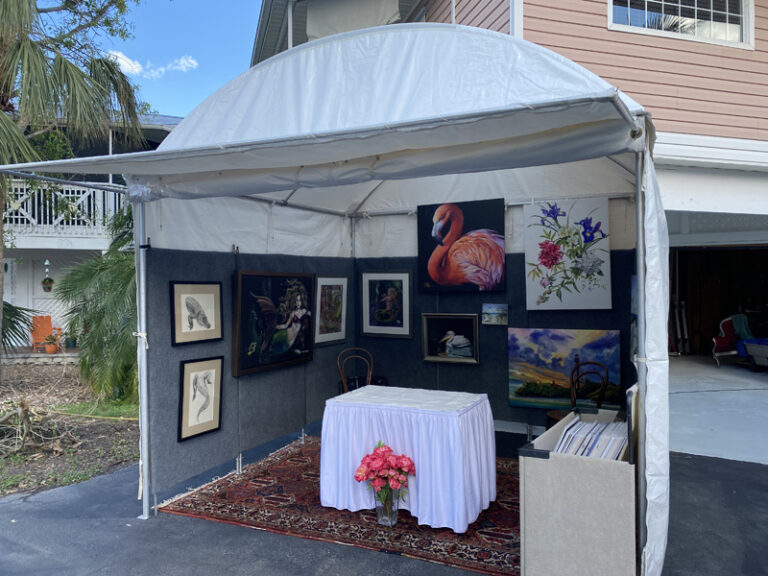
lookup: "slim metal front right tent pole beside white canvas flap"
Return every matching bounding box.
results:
[635,153,647,560]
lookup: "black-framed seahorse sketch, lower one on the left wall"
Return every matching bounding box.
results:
[179,356,224,442]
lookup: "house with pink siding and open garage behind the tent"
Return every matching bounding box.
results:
[252,0,768,354]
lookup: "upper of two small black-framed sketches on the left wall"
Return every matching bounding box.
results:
[171,282,222,346]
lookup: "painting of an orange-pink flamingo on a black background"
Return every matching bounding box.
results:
[427,200,504,291]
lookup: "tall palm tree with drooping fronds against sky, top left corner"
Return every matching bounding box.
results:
[0,0,141,366]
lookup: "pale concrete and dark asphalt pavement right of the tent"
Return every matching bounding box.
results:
[663,356,768,576]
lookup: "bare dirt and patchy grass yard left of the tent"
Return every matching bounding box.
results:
[0,365,139,496]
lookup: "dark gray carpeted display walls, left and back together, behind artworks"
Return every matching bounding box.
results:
[147,249,636,491]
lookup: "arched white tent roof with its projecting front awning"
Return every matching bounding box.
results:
[0,24,644,209]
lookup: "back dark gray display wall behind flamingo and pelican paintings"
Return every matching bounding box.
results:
[355,250,636,425]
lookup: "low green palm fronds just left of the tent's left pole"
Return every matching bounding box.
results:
[54,209,138,400]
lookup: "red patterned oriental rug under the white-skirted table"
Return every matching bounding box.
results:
[159,436,520,575]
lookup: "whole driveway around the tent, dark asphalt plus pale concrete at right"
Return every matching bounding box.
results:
[0,357,768,576]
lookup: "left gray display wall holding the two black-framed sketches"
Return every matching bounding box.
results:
[147,249,354,491]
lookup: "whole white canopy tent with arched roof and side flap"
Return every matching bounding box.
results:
[0,24,669,575]
